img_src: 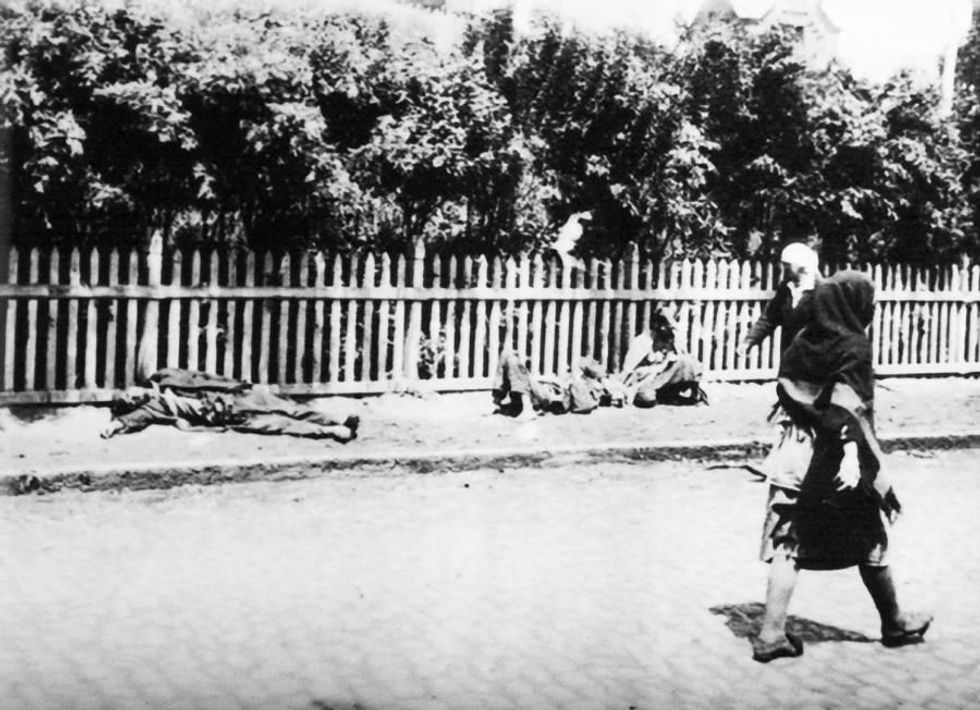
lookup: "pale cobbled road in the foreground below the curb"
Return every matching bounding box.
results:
[0,452,980,710]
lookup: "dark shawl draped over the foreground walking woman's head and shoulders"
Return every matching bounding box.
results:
[777,271,900,514]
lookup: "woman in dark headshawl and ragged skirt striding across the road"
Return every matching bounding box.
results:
[752,271,932,663]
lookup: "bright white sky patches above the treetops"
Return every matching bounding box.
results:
[528,0,973,79]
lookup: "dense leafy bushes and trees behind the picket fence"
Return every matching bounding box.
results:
[0,6,980,263]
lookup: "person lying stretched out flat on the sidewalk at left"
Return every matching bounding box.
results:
[102,368,360,443]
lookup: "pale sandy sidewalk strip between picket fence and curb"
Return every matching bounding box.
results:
[0,377,980,474]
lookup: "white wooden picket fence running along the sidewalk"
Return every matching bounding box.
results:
[0,240,980,403]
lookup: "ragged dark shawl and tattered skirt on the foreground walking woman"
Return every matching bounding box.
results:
[761,272,900,568]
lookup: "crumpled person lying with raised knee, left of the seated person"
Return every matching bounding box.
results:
[492,348,621,420]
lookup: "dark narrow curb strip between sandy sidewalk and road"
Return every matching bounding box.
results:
[7,432,980,495]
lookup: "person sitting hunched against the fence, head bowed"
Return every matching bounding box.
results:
[619,311,708,408]
